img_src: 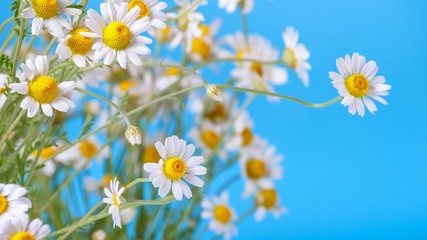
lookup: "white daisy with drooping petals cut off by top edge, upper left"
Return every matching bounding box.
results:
[22,0,82,38]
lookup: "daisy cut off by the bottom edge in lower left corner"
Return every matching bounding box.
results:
[0,214,50,240]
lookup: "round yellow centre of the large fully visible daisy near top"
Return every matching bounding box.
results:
[102,22,132,50]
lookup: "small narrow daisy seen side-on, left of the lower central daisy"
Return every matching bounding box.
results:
[102,178,125,228]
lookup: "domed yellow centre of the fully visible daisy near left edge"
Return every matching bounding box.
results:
[28,76,58,103]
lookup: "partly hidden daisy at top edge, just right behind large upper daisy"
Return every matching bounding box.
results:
[115,0,168,37]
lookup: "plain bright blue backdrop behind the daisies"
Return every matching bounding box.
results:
[0,0,427,239]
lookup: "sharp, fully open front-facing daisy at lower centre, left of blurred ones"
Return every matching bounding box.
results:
[144,136,207,200]
